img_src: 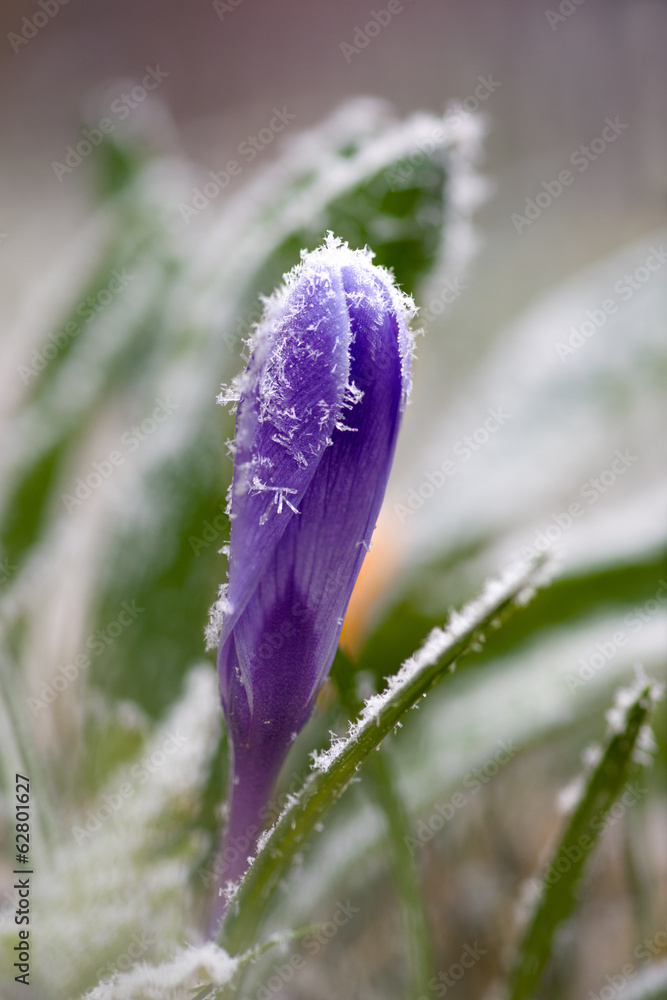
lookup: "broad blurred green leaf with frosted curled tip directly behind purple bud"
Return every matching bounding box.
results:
[85,101,474,715]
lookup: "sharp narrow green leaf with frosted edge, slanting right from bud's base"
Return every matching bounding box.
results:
[220,562,542,954]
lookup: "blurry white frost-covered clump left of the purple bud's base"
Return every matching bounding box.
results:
[24,664,220,1000]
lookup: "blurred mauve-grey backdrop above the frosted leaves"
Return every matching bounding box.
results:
[1,0,667,376]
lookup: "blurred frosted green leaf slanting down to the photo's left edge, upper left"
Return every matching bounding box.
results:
[0,190,176,580]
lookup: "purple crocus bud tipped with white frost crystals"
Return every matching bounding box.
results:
[209,234,415,916]
